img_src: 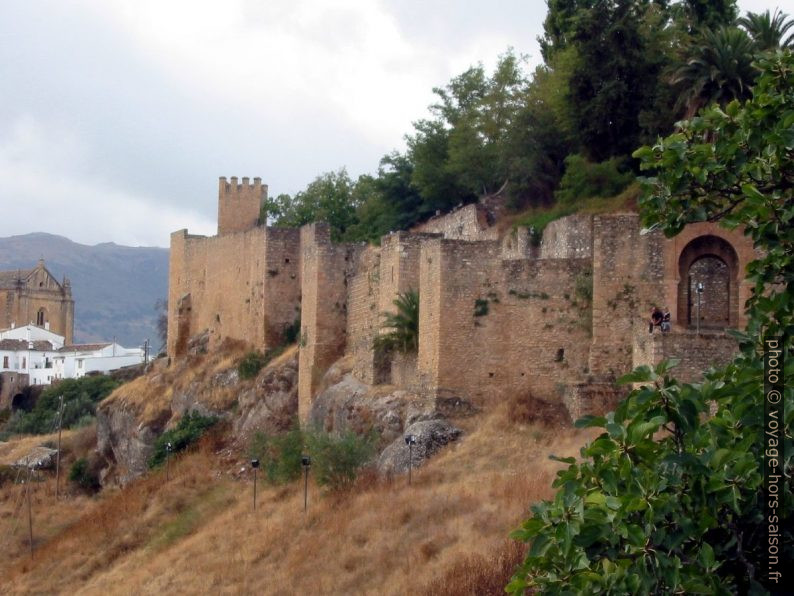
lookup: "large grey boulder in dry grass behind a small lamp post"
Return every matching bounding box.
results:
[378,419,463,476]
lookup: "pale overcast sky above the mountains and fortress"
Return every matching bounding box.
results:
[0,0,778,246]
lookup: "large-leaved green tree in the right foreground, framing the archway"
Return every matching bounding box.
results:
[508,51,794,594]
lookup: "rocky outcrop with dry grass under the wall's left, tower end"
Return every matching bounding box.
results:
[97,348,298,484]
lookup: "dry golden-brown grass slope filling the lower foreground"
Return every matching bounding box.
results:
[0,402,588,594]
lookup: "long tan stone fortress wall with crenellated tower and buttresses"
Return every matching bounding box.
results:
[168,178,755,419]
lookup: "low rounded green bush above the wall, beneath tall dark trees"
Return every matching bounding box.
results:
[555,155,635,205]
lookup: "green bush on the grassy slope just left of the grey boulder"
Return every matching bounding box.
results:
[305,432,375,490]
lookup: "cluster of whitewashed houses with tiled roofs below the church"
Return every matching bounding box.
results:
[0,325,144,385]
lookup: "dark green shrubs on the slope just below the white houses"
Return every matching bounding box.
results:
[7,375,121,434]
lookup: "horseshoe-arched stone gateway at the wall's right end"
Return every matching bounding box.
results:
[677,235,740,329]
